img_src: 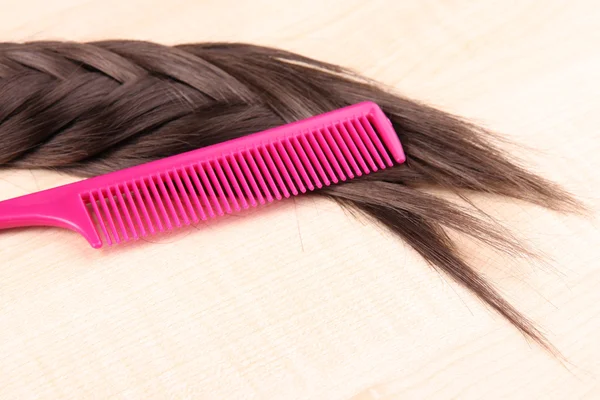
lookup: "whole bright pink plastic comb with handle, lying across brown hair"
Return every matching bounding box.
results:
[0,102,405,248]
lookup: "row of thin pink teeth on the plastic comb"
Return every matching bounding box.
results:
[82,104,403,245]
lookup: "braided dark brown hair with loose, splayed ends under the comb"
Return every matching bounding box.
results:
[0,41,577,346]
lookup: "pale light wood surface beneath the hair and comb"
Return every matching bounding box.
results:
[0,0,600,400]
